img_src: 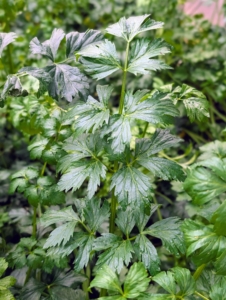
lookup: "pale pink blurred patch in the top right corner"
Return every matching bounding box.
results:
[184,0,225,27]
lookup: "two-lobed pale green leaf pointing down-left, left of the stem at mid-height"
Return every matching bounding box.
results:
[58,159,107,199]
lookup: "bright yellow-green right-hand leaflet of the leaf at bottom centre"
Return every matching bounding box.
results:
[124,262,150,299]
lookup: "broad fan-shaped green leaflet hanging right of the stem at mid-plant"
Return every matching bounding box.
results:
[110,165,151,203]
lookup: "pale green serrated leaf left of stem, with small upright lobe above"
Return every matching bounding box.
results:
[71,85,113,133]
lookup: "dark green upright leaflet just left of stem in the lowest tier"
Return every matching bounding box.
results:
[84,199,109,231]
